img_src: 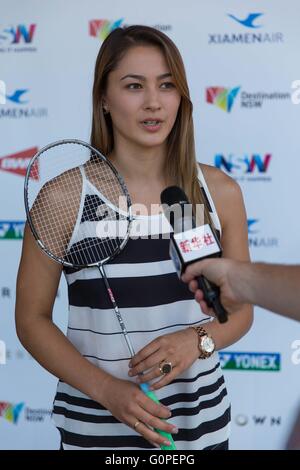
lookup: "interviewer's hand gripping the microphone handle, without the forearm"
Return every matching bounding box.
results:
[182,258,245,316]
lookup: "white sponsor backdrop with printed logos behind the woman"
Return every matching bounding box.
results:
[0,0,300,449]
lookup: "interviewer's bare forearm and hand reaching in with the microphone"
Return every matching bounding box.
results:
[183,259,300,321]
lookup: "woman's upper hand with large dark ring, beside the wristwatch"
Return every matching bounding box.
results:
[128,328,199,390]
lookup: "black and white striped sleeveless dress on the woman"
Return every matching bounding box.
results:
[53,165,230,450]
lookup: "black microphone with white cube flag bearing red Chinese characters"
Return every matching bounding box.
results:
[160,186,228,323]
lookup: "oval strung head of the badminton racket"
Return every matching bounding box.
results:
[24,139,133,268]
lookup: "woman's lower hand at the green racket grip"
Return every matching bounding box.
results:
[99,376,178,447]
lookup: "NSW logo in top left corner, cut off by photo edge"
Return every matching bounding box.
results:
[0,24,37,53]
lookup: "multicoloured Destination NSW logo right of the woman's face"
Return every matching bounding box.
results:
[205,86,291,113]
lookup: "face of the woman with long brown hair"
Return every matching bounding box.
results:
[104,46,181,148]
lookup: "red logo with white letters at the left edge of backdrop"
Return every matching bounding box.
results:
[0,147,39,180]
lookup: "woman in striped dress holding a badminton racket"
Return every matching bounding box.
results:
[16,26,252,449]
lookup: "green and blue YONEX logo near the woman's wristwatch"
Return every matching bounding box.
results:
[219,351,281,372]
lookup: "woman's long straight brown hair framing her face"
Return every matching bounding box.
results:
[91,25,210,220]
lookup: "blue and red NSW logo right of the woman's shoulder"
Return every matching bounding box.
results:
[215,153,272,182]
